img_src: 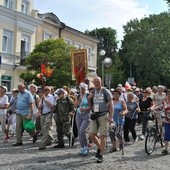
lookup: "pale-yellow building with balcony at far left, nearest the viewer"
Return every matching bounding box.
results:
[0,0,41,91]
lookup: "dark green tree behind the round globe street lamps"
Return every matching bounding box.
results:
[85,27,124,86]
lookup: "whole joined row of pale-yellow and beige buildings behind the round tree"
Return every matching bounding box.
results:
[0,0,99,91]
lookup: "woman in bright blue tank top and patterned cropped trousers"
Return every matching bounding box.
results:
[109,90,127,153]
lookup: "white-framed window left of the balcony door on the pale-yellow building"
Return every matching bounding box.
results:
[2,29,13,54]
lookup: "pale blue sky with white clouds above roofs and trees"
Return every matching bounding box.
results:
[34,0,168,41]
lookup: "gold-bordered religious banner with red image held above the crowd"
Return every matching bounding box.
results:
[71,49,87,85]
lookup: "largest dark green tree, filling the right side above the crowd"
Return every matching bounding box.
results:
[119,13,170,86]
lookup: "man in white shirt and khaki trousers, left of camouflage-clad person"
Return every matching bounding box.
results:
[38,86,55,150]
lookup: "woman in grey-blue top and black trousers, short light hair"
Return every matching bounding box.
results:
[123,92,140,143]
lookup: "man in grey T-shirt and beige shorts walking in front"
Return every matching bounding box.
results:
[89,77,113,163]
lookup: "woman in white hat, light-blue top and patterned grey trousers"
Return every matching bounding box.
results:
[75,83,90,156]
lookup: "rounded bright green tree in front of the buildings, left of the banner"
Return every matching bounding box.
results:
[20,39,73,87]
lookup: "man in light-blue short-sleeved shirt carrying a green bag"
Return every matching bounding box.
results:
[13,83,37,146]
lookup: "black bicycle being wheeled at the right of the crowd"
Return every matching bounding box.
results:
[145,111,164,155]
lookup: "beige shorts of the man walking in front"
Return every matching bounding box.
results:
[89,114,108,136]
